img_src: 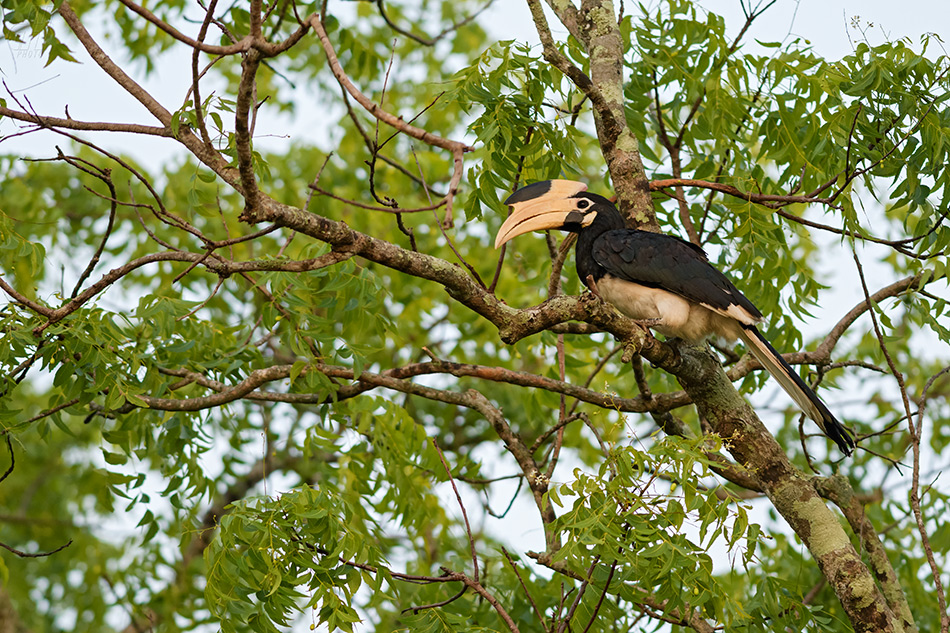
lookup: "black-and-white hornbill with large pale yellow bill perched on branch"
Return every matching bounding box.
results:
[495,180,854,455]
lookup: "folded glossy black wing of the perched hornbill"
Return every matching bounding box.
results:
[591,229,762,320]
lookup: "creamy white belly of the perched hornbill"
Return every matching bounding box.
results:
[597,275,739,343]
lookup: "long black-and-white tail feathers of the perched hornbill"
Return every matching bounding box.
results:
[739,325,854,455]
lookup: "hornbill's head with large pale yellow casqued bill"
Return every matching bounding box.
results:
[495,180,619,248]
